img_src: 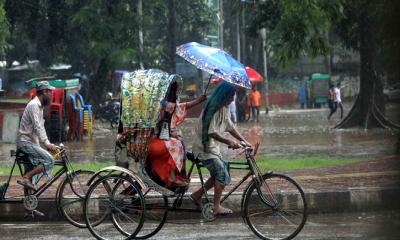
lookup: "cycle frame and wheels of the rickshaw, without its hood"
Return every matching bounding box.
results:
[84,142,307,240]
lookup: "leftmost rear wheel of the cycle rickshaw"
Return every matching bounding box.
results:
[84,174,145,240]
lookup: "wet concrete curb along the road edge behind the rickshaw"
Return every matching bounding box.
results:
[0,187,400,222]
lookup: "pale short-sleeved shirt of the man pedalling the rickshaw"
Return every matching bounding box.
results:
[192,107,234,160]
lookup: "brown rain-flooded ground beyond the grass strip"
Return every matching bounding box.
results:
[0,101,400,166]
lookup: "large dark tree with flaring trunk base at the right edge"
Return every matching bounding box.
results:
[336,0,400,129]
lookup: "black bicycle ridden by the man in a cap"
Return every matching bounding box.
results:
[0,144,94,228]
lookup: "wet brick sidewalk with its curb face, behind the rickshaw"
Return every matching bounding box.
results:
[0,156,400,221]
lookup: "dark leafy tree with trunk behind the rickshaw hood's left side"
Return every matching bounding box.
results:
[72,0,139,103]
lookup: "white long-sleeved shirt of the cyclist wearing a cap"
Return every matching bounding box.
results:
[17,97,50,145]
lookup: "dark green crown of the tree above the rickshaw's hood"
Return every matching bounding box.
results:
[72,0,138,68]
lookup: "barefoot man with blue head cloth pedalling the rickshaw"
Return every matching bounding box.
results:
[190,82,251,215]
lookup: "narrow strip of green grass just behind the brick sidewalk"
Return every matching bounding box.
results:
[0,156,362,176]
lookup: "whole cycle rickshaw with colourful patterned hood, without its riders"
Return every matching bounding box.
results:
[83,69,307,240]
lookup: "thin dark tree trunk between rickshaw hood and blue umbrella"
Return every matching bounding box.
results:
[167,0,176,73]
